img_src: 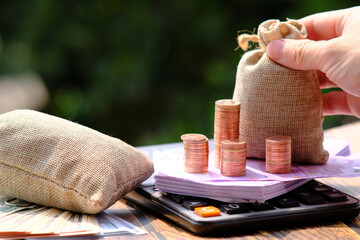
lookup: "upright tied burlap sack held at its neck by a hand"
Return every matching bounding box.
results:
[233,20,328,164]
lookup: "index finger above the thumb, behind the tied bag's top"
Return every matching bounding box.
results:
[299,8,354,41]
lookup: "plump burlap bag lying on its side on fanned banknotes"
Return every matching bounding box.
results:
[0,110,153,214]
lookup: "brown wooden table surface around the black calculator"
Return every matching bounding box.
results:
[111,121,360,240]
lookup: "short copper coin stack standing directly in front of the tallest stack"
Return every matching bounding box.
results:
[220,139,246,177]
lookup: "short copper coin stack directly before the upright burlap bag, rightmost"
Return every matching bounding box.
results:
[266,136,291,173]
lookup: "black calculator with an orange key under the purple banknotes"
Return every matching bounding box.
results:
[125,180,360,235]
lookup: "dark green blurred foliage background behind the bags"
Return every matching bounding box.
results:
[0,0,358,146]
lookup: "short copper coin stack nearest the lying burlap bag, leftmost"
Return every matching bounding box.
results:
[181,133,209,173]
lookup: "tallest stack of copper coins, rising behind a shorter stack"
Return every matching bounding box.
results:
[214,99,240,168]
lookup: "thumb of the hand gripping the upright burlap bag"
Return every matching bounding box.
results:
[266,39,326,70]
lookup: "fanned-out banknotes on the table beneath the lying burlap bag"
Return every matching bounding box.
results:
[0,196,145,239]
